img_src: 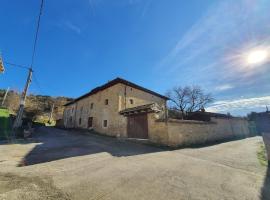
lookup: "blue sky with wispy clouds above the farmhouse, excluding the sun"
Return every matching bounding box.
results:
[0,0,270,115]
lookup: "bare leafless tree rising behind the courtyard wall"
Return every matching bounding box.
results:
[167,86,214,118]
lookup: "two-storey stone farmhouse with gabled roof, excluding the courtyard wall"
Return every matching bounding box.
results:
[63,78,168,138]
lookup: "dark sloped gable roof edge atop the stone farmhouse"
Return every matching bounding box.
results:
[65,78,169,106]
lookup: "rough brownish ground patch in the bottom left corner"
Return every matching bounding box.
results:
[0,173,70,200]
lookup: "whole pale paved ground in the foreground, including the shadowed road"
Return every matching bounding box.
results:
[0,128,270,200]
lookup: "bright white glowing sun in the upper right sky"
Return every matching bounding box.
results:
[247,49,269,65]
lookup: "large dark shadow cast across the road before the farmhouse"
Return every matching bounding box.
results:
[18,127,165,166]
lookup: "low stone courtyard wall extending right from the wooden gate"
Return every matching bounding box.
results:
[148,113,249,147]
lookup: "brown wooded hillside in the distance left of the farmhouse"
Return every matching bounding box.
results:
[0,89,72,120]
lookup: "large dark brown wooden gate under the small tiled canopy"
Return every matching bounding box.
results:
[127,113,148,139]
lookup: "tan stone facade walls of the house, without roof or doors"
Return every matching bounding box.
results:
[63,83,166,137]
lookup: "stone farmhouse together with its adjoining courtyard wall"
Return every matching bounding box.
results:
[63,78,249,147]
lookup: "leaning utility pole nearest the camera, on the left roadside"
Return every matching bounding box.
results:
[13,68,33,129]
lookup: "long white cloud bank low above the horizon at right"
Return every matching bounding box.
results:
[206,96,270,112]
